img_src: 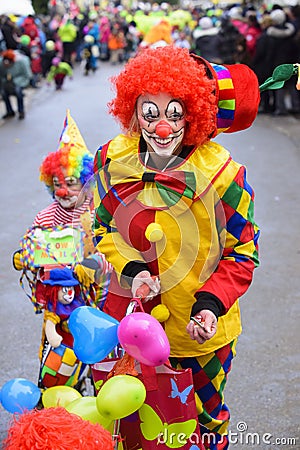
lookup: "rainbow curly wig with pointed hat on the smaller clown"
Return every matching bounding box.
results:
[40,111,94,194]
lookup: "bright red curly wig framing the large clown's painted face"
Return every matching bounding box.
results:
[108,45,217,145]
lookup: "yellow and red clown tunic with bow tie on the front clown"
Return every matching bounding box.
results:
[96,135,258,357]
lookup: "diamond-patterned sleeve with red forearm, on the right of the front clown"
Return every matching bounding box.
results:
[199,166,260,314]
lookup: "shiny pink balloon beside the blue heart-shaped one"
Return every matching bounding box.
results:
[118,312,170,366]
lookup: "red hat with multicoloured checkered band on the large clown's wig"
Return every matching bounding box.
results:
[191,54,260,137]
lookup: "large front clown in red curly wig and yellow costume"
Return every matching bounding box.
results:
[94,46,259,449]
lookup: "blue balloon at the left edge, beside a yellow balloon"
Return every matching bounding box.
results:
[1,378,41,414]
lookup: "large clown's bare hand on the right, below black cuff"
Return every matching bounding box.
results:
[186,309,218,344]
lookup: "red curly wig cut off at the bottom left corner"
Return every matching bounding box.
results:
[3,407,114,450]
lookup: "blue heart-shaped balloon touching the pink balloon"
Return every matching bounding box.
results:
[69,306,119,364]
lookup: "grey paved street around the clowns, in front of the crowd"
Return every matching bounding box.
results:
[0,63,300,450]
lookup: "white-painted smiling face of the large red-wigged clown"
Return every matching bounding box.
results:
[137,93,186,158]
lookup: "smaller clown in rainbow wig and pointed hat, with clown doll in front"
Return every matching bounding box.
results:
[13,110,111,391]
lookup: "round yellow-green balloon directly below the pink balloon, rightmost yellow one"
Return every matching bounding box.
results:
[96,375,146,420]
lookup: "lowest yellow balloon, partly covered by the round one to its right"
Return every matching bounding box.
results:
[66,396,111,429]
